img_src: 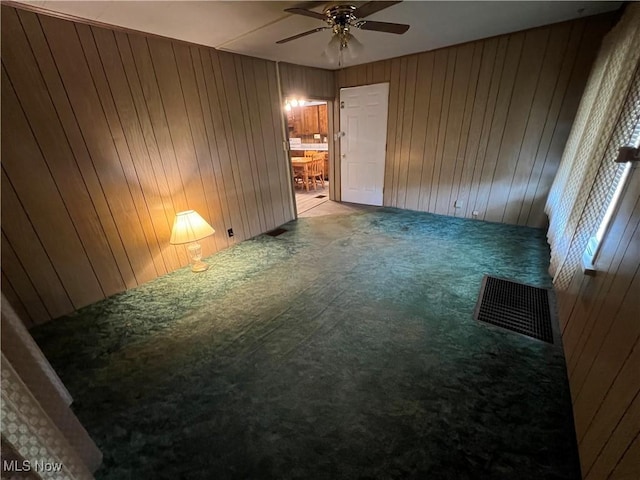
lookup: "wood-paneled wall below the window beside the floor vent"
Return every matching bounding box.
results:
[559,167,640,480]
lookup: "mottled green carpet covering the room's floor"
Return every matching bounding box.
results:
[32,208,580,480]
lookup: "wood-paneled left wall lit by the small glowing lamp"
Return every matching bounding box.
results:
[2,6,293,324]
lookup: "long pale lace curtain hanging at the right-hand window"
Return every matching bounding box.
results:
[545,3,640,290]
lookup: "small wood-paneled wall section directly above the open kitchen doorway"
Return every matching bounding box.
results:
[278,62,336,100]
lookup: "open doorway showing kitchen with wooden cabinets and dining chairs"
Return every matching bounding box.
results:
[285,98,331,215]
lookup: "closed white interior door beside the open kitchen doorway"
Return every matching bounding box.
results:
[340,83,389,205]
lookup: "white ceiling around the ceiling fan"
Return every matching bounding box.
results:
[13,0,622,69]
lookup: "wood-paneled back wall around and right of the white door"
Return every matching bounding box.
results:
[337,15,613,227]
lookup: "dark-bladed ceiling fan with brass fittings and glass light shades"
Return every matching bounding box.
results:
[276,1,409,62]
